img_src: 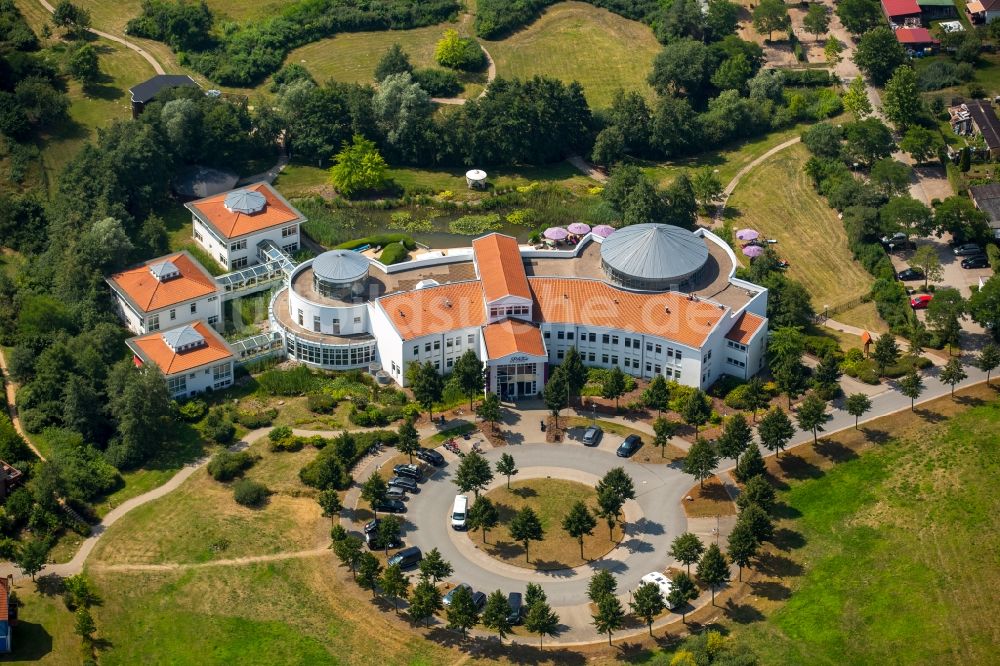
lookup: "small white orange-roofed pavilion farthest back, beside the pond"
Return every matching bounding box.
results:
[184,183,306,271]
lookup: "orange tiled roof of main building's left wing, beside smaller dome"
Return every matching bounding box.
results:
[378,281,486,340]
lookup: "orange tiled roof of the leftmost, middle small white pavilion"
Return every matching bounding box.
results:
[108,252,216,312]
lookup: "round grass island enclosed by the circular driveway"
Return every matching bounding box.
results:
[468,477,621,571]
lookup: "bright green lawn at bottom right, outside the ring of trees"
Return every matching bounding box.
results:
[741,391,1000,664]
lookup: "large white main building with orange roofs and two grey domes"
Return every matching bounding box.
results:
[270,224,767,399]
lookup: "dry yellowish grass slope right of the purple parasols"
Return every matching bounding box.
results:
[727,145,872,311]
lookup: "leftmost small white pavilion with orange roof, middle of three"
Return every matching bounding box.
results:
[107,252,222,335]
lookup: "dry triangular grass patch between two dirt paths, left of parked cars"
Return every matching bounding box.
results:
[92,441,329,565]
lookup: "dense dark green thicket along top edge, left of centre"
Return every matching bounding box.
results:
[127,0,459,86]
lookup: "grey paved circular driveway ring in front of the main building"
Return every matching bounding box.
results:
[405,438,693,607]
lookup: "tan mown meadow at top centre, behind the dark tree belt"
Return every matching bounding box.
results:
[483,2,662,108]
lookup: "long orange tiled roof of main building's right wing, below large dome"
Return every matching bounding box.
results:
[528,278,725,347]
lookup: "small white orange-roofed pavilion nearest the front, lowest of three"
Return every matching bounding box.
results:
[125,321,236,398]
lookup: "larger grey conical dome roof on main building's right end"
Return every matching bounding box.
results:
[601,223,708,281]
